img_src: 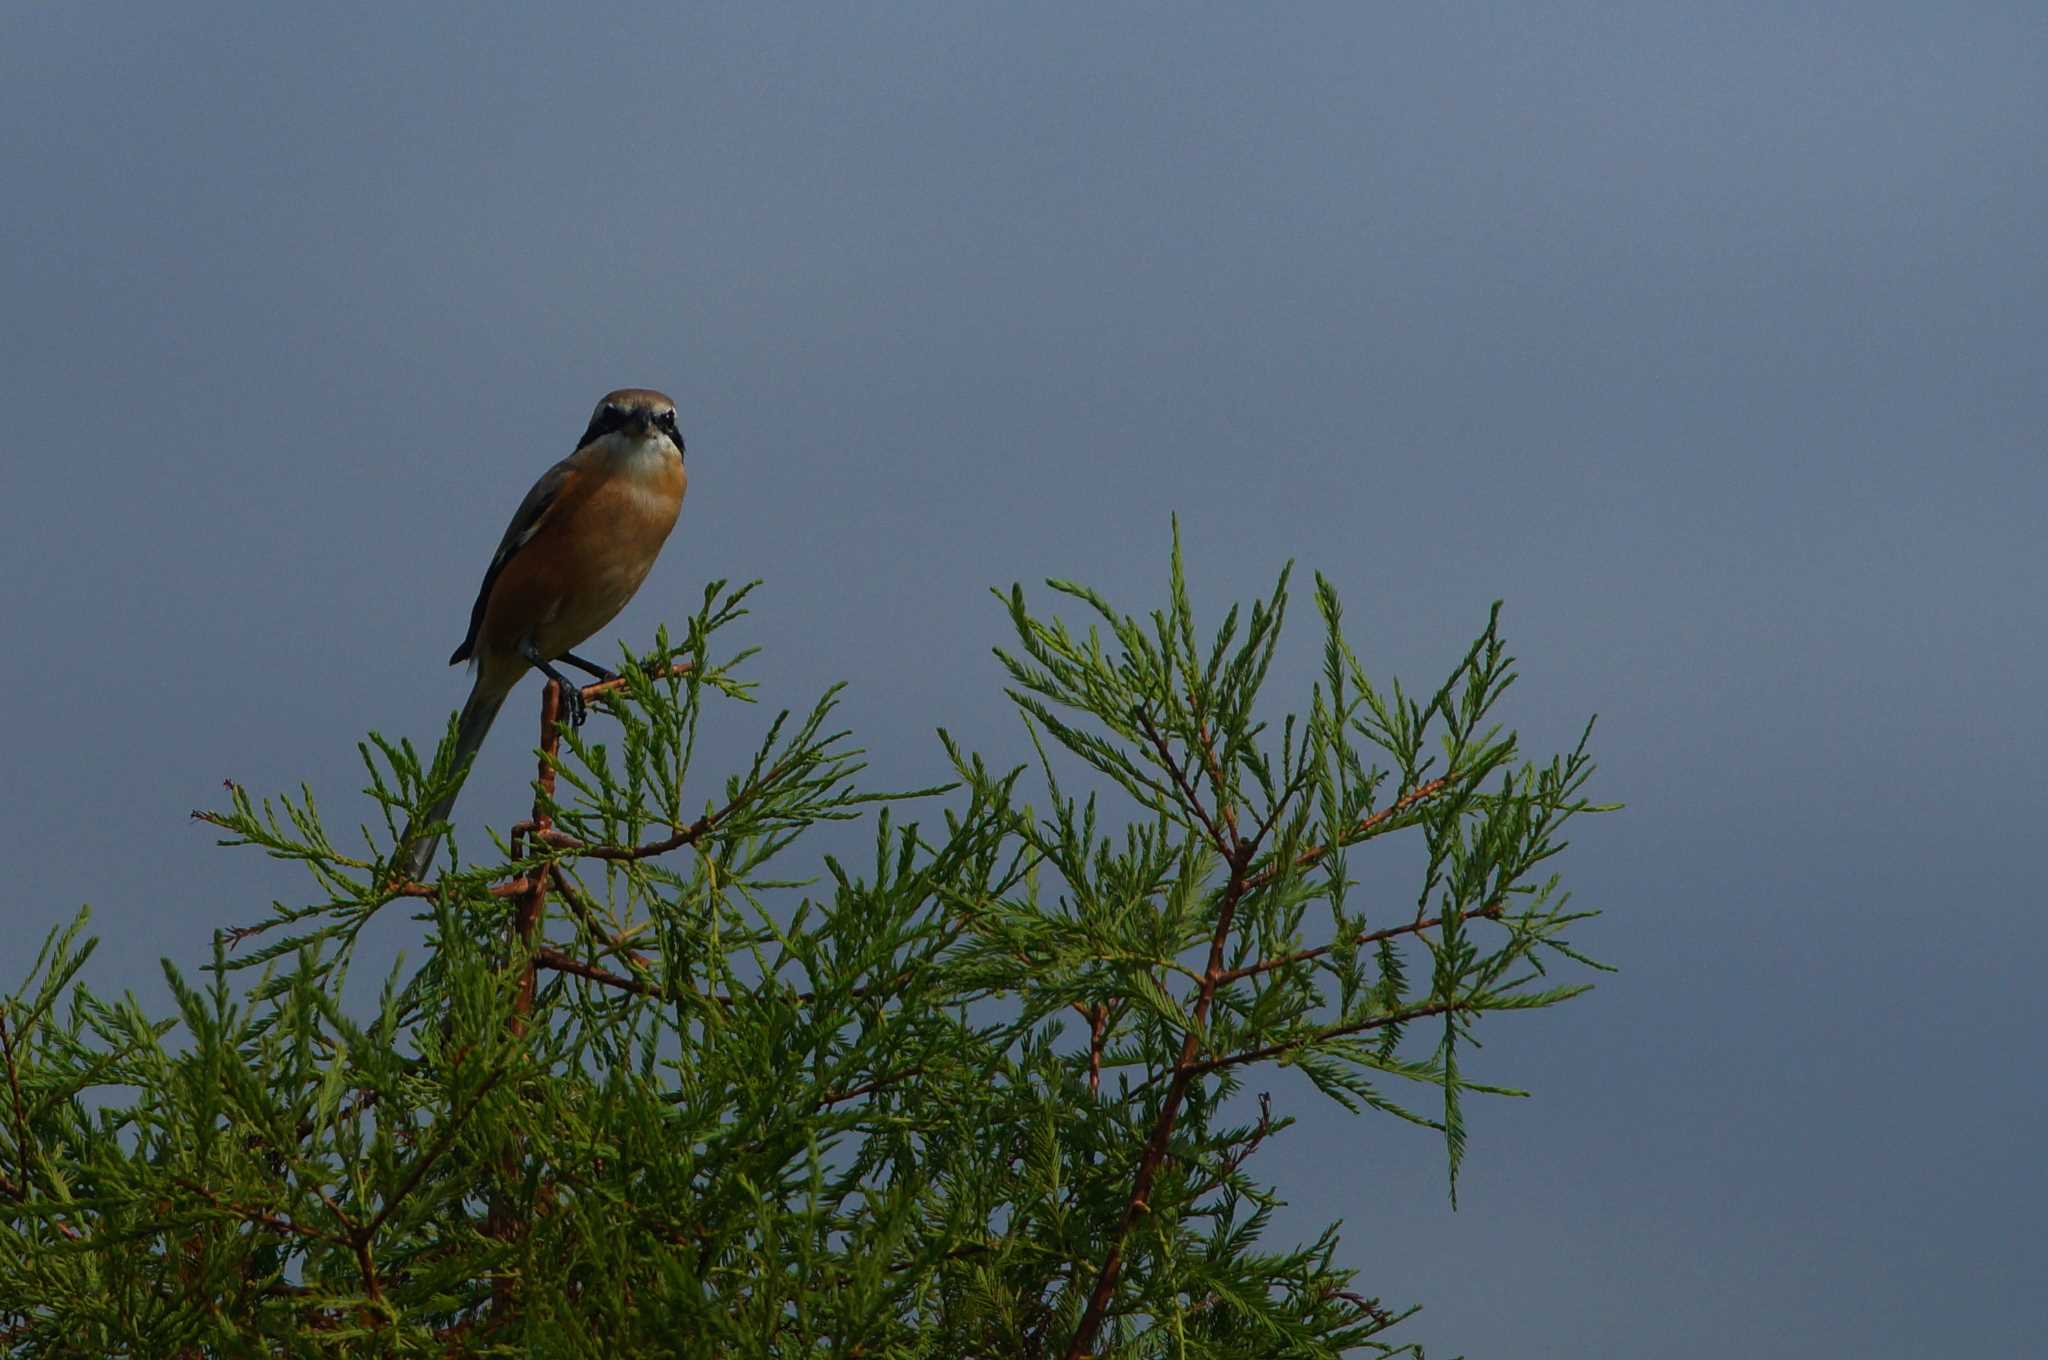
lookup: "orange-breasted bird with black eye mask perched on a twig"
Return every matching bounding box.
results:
[397,387,690,881]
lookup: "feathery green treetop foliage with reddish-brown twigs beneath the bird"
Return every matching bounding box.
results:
[0,543,1597,1360]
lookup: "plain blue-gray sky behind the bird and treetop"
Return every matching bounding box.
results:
[0,0,2048,1358]
